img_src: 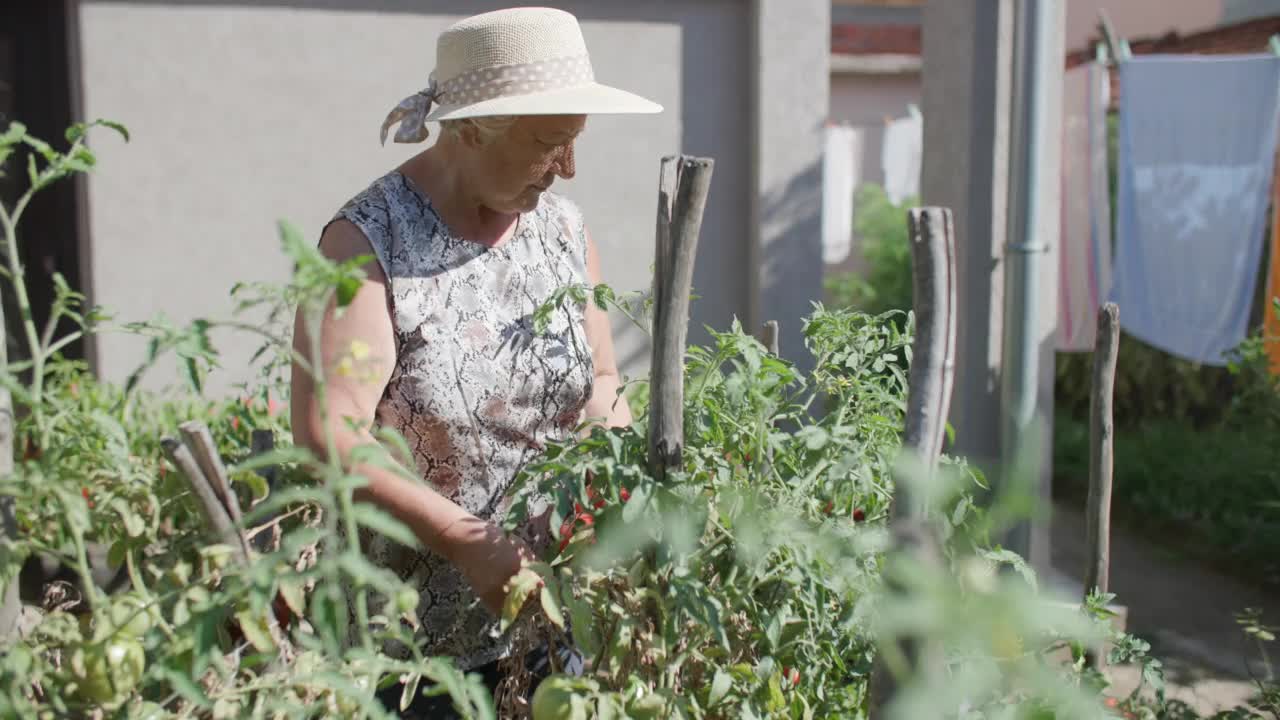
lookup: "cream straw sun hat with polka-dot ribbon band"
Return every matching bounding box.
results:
[381,8,662,143]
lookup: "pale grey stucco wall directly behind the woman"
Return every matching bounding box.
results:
[79,0,757,389]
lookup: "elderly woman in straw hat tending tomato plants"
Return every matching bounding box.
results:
[292,8,660,717]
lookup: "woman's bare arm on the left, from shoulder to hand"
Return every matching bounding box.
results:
[289,220,530,612]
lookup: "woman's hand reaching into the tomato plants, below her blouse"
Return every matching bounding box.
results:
[447,518,534,615]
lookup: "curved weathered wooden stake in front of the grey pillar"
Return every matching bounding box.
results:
[868,208,956,717]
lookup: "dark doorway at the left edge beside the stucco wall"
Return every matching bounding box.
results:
[0,0,86,361]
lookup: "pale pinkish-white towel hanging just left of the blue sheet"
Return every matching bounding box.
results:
[1057,63,1111,352]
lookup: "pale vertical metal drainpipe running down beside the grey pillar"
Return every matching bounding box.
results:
[1001,0,1064,557]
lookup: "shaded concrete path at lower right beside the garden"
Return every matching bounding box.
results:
[1051,502,1280,714]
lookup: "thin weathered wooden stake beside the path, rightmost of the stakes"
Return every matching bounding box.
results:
[1084,302,1120,667]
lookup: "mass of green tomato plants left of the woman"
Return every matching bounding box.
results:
[0,123,493,719]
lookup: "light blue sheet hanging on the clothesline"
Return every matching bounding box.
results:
[1111,55,1280,365]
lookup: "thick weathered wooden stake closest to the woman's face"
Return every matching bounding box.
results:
[649,155,714,479]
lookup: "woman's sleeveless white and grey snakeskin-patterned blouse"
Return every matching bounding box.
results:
[334,172,594,669]
